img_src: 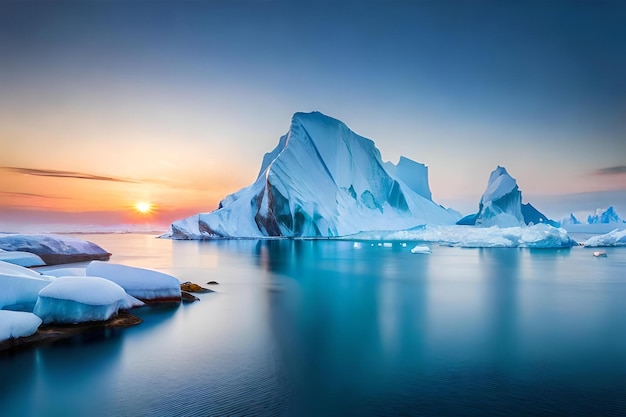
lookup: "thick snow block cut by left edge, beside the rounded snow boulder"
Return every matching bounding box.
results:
[0,261,54,310]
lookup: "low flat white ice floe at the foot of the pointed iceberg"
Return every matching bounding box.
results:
[346,224,576,248]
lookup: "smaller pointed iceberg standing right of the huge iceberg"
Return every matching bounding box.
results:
[457,166,558,227]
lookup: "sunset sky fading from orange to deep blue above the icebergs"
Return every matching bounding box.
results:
[0,0,626,230]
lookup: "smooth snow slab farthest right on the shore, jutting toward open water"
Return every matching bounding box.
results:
[86,261,180,301]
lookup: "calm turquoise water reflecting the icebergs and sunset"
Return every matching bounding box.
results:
[0,234,626,417]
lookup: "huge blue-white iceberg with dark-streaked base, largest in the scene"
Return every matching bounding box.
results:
[170,112,456,239]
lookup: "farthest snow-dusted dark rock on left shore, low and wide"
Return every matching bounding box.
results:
[0,233,111,265]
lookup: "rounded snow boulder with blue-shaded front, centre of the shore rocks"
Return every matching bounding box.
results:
[33,276,143,323]
